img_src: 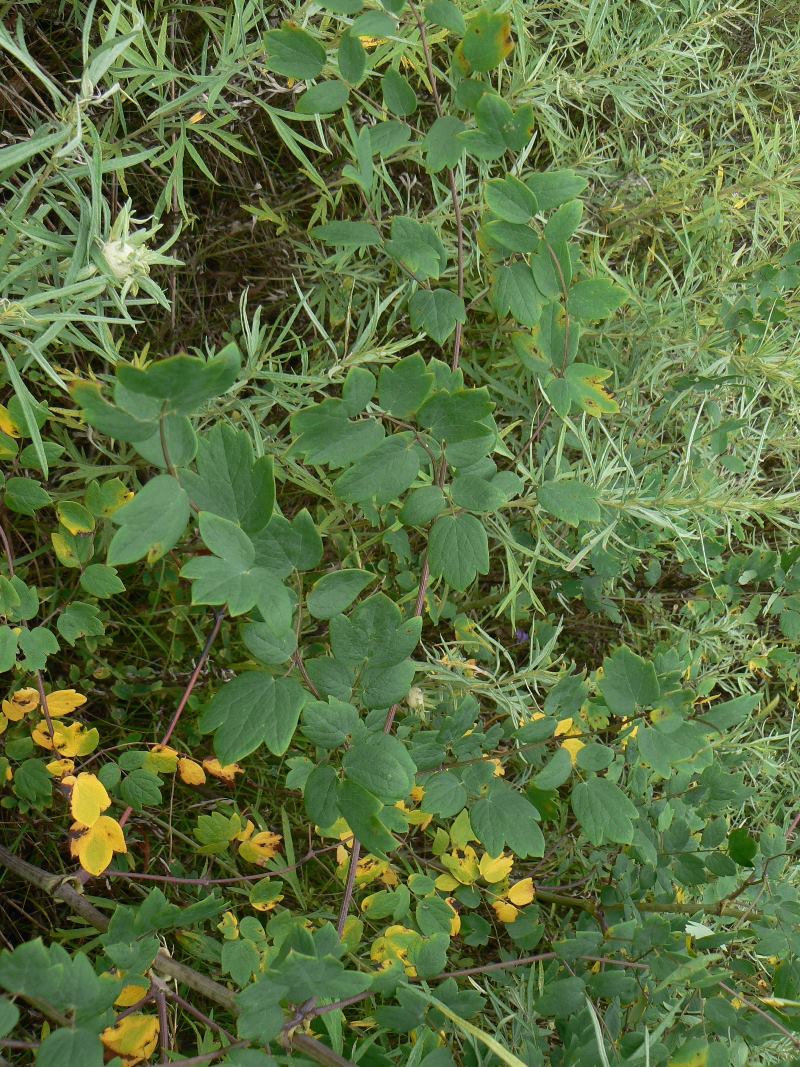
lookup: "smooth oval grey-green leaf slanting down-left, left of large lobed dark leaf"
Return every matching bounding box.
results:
[107,474,189,566]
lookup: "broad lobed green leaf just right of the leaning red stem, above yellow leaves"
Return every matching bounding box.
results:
[199,671,305,764]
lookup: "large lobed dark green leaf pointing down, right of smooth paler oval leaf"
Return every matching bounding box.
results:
[180,424,275,534]
